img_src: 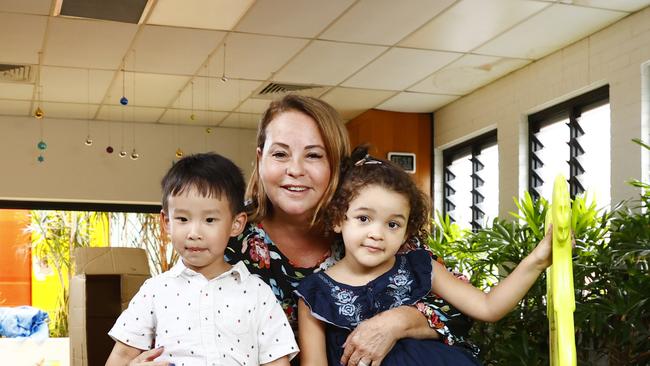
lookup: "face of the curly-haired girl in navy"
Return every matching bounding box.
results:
[334,185,410,273]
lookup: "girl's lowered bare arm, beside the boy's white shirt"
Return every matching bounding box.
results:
[298,299,327,366]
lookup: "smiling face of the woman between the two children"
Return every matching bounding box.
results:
[257,111,331,220]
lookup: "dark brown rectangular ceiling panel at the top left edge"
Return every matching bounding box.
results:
[59,0,148,24]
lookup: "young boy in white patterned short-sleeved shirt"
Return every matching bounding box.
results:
[106,153,298,366]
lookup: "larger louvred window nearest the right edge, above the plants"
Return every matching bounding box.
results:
[528,86,611,207]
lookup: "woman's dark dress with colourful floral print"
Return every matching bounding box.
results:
[225,223,478,358]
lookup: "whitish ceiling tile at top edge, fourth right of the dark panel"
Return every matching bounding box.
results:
[399,0,550,52]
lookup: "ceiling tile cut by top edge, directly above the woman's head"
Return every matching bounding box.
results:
[235,0,354,38]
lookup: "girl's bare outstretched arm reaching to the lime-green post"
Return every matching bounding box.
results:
[431,228,553,322]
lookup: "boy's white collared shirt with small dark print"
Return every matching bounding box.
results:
[108,260,298,365]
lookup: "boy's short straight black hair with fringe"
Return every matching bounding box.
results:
[160,152,246,216]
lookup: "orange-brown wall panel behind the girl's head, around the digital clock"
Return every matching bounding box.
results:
[347,109,431,194]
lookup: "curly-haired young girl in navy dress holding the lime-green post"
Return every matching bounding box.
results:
[296,148,551,366]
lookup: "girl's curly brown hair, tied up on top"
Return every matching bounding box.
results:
[325,145,430,239]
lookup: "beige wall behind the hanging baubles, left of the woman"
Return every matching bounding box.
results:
[0,116,255,204]
